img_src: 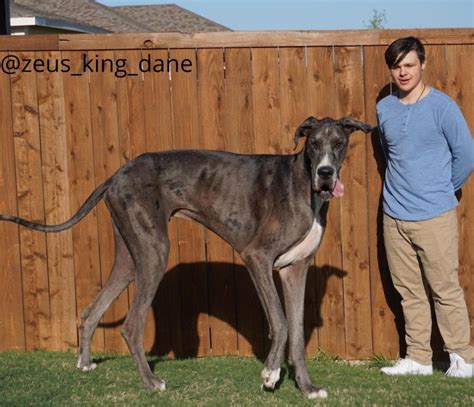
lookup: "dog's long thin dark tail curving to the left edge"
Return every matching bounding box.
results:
[0,178,112,233]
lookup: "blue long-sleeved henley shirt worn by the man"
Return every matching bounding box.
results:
[377,88,474,221]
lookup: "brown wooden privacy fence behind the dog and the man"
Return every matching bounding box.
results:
[0,29,474,359]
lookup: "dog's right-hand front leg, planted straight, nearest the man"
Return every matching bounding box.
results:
[280,256,327,399]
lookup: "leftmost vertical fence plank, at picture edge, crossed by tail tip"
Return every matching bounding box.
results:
[0,52,27,351]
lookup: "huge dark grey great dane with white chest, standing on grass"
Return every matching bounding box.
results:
[0,117,372,398]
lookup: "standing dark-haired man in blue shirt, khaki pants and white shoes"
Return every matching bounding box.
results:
[377,37,474,377]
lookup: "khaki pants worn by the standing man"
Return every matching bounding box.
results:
[383,210,474,364]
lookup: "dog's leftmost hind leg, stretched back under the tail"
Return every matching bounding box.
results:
[77,226,135,371]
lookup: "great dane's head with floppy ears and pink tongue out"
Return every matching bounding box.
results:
[295,117,372,201]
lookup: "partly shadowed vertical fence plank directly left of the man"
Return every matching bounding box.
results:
[364,46,403,358]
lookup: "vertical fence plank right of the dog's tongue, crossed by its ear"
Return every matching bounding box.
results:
[335,47,372,359]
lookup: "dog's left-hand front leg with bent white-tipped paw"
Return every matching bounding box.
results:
[241,252,288,389]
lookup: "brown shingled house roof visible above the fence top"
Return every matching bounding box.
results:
[10,0,229,32]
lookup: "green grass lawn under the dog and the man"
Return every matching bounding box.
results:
[0,351,474,407]
